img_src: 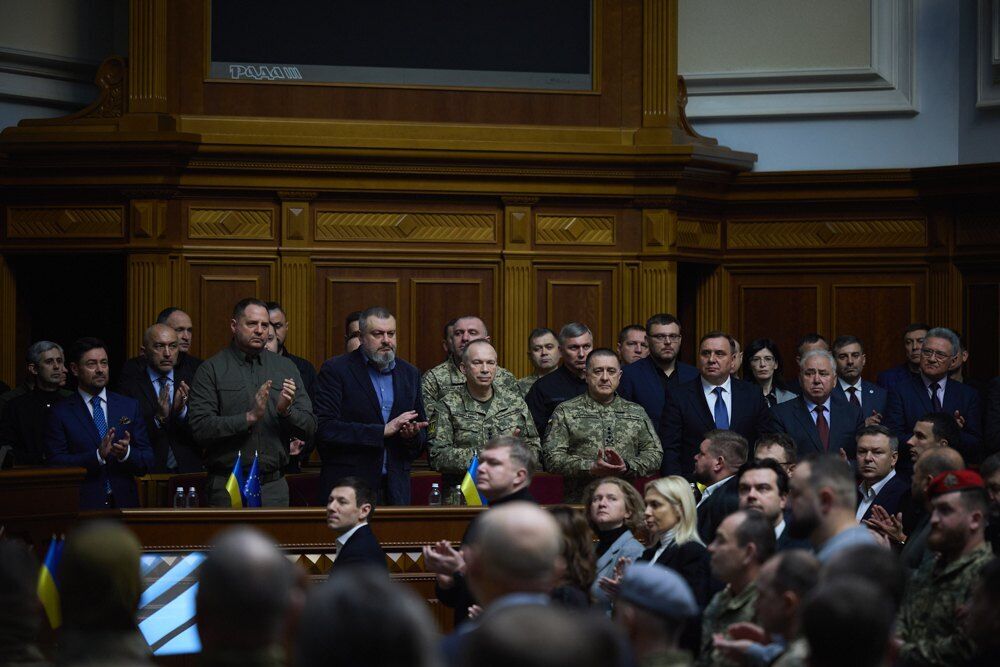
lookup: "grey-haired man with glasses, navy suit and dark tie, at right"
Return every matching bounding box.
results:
[885,327,983,473]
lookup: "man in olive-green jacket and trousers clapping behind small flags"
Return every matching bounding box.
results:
[188,299,316,507]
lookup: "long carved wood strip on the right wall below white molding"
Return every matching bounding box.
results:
[727,219,927,249]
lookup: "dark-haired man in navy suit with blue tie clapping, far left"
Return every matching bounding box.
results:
[44,338,153,509]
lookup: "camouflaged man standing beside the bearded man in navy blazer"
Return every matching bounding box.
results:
[428,339,540,486]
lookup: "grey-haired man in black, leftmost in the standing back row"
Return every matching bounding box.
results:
[0,340,73,466]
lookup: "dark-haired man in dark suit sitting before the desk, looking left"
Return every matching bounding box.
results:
[326,477,387,570]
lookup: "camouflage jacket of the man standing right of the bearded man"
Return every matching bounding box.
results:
[427,383,540,473]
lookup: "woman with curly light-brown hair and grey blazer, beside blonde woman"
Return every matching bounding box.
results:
[583,477,646,613]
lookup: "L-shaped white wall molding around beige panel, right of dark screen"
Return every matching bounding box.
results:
[681,0,916,119]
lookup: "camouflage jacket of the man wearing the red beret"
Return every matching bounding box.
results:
[898,544,993,665]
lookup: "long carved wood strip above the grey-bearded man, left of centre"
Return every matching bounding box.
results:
[316,211,497,243]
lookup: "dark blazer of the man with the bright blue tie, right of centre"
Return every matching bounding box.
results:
[659,375,773,479]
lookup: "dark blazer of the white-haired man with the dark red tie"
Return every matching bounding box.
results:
[771,394,865,460]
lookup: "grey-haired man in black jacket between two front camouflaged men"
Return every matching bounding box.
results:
[524,322,594,433]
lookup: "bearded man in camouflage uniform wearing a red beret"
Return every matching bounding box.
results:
[897,470,993,666]
